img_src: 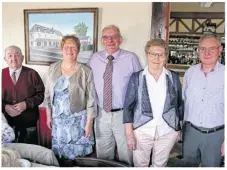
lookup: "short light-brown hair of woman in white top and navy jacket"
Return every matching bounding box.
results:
[145,39,169,57]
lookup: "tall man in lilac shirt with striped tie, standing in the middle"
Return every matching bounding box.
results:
[88,25,141,165]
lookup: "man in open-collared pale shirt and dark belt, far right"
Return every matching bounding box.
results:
[183,34,225,167]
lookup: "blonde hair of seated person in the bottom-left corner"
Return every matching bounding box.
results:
[2,147,20,167]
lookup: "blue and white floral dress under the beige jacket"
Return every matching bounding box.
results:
[52,76,94,159]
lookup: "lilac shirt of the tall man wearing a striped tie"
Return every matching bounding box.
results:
[88,49,141,109]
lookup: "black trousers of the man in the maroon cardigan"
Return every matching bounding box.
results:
[14,126,38,144]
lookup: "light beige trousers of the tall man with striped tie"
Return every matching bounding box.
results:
[95,108,133,166]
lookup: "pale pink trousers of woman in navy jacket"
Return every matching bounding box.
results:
[133,125,179,167]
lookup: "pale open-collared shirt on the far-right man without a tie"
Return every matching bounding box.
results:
[183,62,225,128]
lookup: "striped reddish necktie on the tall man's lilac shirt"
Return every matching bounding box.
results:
[103,55,114,112]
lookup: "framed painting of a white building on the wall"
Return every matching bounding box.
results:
[24,8,98,65]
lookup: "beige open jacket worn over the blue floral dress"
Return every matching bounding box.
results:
[44,60,97,118]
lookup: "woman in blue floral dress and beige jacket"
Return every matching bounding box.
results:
[45,35,96,160]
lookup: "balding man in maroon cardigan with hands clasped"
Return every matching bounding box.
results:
[2,46,44,144]
